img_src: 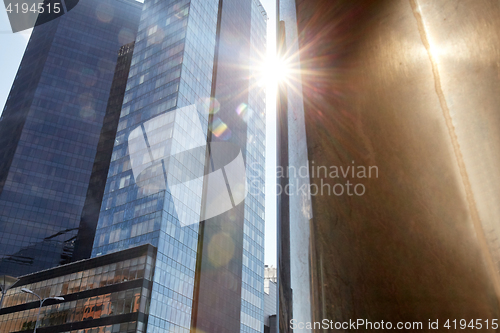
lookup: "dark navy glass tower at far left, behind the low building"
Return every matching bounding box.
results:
[0,0,141,276]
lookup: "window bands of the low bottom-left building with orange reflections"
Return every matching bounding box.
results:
[0,255,153,333]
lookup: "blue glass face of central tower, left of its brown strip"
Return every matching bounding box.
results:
[92,0,218,332]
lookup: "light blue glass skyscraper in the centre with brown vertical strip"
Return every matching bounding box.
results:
[92,0,267,333]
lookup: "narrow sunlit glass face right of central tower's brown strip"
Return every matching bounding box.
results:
[239,0,267,333]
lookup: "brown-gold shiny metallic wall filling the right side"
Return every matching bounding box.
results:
[280,0,500,324]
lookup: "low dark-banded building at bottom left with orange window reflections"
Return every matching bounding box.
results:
[0,244,156,333]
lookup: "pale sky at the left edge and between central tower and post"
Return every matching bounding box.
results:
[0,0,277,267]
